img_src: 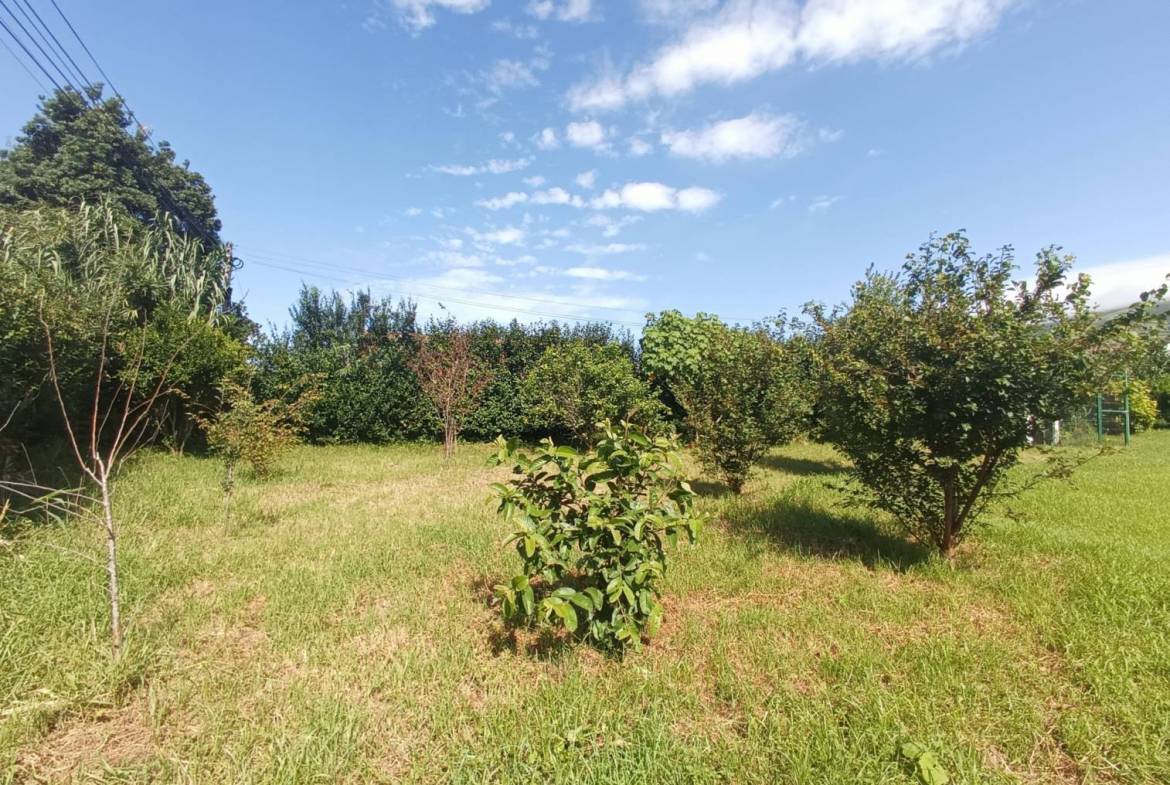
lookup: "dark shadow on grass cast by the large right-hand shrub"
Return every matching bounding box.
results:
[727,494,930,572]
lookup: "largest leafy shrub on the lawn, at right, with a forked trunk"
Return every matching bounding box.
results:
[810,233,1152,556]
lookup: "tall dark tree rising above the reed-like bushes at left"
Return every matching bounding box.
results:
[0,85,220,243]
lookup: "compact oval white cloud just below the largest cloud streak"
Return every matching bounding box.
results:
[662,112,806,161]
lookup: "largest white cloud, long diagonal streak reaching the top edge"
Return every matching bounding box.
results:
[567,0,1019,111]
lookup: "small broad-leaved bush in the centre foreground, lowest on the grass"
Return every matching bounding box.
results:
[493,424,702,650]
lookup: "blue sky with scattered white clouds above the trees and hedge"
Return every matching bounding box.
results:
[0,0,1170,325]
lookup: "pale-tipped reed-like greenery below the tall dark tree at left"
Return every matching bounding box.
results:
[0,201,237,447]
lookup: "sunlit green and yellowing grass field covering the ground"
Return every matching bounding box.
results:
[0,432,1170,785]
